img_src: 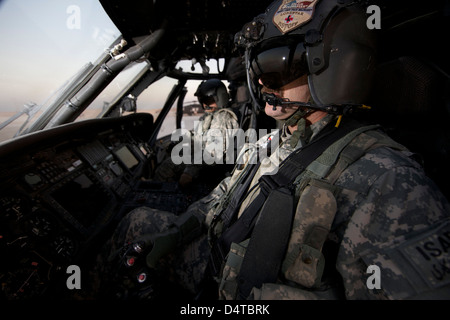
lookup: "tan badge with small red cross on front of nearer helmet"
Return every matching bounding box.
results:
[273,0,318,34]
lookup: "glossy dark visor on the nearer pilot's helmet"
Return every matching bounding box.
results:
[249,42,308,89]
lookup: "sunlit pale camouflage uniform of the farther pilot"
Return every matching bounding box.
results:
[154,108,239,181]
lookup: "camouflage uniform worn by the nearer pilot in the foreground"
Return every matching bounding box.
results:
[106,115,450,299]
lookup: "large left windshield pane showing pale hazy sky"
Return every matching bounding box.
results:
[0,0,120,142]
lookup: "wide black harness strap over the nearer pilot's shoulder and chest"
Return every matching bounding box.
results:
[239,121,386,298]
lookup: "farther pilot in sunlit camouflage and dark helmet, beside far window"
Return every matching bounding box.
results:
[154,79,239,188]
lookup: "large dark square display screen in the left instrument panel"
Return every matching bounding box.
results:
[51,174,109,227]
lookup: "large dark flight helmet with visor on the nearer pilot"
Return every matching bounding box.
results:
[235,0,376,110]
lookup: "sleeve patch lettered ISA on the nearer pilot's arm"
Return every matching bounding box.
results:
[361,219,450,299]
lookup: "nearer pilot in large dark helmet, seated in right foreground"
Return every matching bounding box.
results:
[97,0,450,299]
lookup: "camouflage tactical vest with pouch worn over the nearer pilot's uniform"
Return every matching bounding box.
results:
[212,125,407,299]
